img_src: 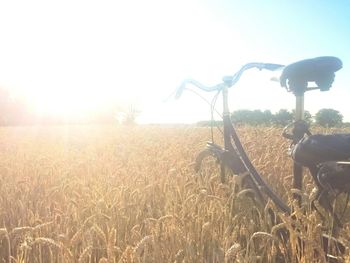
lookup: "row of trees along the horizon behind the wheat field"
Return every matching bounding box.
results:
[0,88,349,127]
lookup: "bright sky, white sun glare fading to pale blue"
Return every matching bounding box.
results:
[0,0,350,123]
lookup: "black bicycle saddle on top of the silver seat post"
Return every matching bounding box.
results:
[280,57,343,95]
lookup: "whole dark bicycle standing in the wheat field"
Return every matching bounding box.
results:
[175,57,350,260]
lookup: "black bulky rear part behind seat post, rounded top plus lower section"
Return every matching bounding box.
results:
[291,134,350,228]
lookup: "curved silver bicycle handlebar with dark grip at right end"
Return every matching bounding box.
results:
[175,62,284,99]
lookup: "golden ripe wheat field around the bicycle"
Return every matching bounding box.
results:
[0,126,350,263]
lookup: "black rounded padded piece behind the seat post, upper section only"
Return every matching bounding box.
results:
[292,133,350,166]
